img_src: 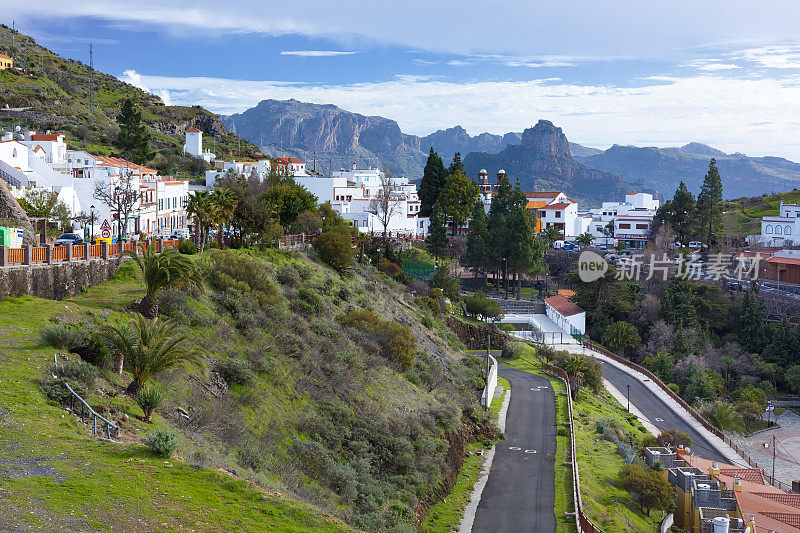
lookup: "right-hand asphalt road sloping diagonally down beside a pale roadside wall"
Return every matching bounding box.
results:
[600,361,730,463]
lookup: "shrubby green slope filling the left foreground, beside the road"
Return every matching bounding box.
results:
[0,250,496,531]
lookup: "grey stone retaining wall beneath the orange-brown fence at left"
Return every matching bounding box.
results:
[0,258,121,300]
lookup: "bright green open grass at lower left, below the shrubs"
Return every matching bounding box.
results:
[0,278,351,532]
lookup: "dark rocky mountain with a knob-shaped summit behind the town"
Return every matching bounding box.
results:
[464,120,646,206]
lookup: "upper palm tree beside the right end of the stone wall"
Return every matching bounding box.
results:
[125,245,202,318]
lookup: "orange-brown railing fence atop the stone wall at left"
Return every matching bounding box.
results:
[0,240,179,267]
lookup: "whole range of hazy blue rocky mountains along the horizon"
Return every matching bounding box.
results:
[222,100,800,200]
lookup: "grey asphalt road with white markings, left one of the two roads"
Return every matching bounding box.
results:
[472,365,556,533]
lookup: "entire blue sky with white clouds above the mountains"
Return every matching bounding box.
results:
[0,0,800,161]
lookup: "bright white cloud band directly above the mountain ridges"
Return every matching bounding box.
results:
[117,71,800,160]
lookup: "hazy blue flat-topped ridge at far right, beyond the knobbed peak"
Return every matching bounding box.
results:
[575,143,800,198]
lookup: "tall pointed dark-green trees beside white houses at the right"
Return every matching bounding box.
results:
[653,159,722,246]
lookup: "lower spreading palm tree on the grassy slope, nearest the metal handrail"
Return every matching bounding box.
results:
[103,313,203,395]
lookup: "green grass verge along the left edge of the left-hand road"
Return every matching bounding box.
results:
[422,377,511,533]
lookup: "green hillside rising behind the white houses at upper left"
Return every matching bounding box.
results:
[0,25,259,174]
